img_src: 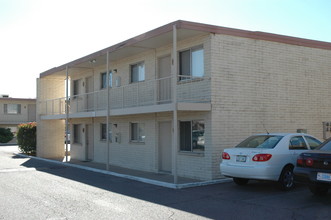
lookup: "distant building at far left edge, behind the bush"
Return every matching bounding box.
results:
[0,95,36,132]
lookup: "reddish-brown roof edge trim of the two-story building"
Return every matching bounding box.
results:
[40,20,331,77]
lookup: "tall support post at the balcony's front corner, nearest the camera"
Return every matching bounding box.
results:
[171,25,178,184]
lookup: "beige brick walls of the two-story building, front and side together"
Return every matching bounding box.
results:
[39,30,331,179]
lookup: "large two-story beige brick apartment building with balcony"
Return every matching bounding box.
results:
[37,21,331,180]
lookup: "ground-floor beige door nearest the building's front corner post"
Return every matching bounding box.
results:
[159,121,172,172]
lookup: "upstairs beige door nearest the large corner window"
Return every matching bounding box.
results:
[158,55,171,104]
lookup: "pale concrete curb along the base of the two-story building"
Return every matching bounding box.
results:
[15,153,232,189]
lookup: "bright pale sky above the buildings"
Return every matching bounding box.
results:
[0,0,331,98]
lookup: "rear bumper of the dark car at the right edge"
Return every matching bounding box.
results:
[293,167,331,188]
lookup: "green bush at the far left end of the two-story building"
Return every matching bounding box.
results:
[17,122,37,154]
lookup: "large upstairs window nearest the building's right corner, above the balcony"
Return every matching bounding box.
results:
[179,46,204,80]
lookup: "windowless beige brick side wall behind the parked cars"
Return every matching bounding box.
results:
[211,35,331,179]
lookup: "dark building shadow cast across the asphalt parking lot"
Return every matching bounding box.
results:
[14,157,331,219]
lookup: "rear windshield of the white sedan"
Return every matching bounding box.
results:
[236,135,283,149]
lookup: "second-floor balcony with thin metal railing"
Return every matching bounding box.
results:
[39,76,211,119]
